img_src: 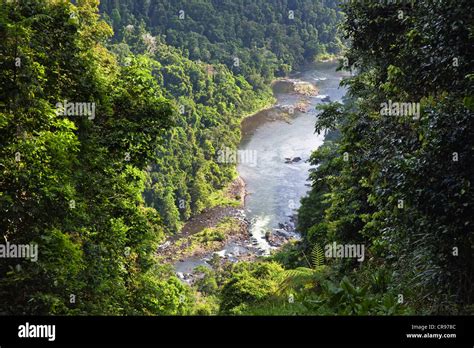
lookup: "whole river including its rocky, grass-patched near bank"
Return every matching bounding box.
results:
[158,63,348,284]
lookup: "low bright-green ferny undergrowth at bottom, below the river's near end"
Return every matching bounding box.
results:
[221,263,412,315]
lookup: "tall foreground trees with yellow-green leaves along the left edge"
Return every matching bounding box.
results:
[0,0,191,315]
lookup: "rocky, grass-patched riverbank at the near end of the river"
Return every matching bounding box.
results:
[157,177,299,284]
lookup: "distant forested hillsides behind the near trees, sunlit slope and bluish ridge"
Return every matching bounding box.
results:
[100,1,342,232]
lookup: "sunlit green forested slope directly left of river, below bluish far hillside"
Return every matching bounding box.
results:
[111,28,273,233]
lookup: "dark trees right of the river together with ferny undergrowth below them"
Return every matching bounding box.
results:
[193,1,474,315]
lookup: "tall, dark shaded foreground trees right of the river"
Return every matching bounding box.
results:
[298,1,474,314]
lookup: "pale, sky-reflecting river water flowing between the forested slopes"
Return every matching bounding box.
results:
[175,62,347,273]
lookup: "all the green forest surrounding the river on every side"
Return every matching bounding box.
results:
[0,0,474,315]
